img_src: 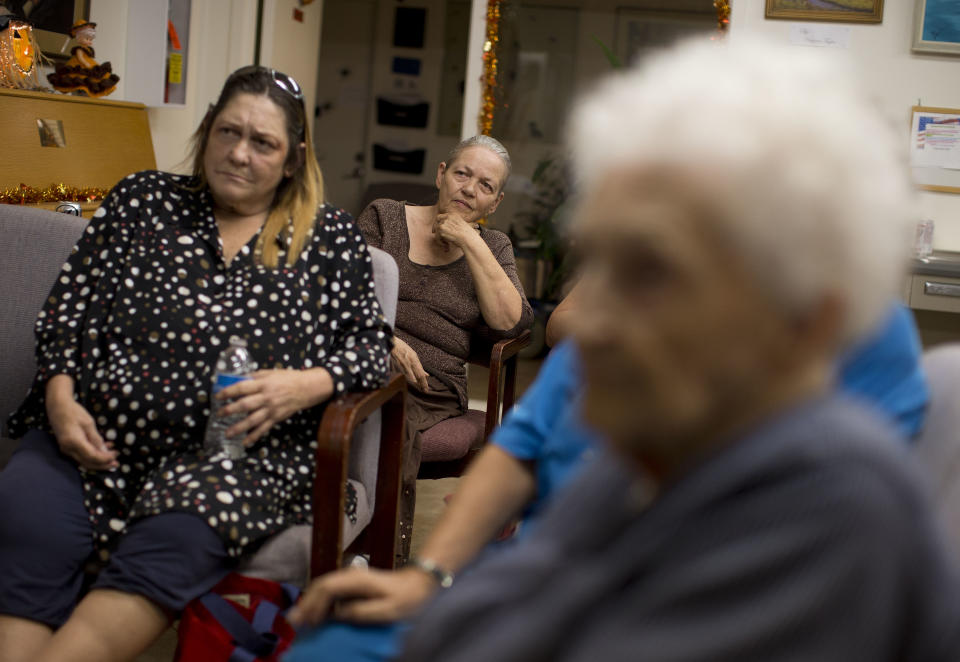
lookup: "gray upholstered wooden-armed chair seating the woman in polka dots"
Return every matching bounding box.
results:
[0,205,406,586]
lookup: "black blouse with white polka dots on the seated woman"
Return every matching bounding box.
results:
[10,171,391,558]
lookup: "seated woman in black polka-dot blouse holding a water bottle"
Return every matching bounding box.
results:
[0,67,390,662]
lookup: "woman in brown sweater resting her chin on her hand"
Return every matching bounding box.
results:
[357,136,533,560]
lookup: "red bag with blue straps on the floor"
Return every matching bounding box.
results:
[173,572,300,662]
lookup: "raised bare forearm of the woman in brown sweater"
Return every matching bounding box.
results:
[462,235,523,331]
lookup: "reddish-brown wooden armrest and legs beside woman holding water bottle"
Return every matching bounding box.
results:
[310,373,407,577]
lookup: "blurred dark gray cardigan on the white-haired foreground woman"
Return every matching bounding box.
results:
[401,400,960,662]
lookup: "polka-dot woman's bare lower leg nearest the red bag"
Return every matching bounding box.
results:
[32,589,170,662]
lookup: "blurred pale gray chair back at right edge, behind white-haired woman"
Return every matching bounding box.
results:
[916,343,960,559]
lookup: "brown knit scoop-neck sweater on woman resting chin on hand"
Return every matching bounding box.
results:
[357,199,533,409]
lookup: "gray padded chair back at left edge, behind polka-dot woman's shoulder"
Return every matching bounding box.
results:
[0,205,87,467]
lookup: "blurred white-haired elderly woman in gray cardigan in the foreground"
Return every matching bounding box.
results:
[390,37,960,662]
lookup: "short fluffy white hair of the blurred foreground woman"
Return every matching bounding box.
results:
[568,38,917,341]
